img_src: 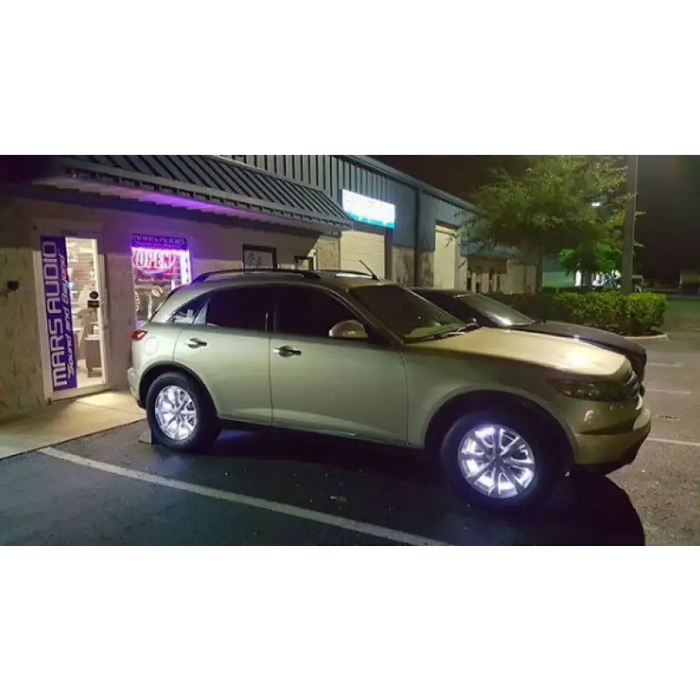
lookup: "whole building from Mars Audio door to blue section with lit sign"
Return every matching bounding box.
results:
[0,152,486,420]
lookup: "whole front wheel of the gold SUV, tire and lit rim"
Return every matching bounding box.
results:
[440,408,566,512]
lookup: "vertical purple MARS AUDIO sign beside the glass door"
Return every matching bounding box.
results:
[41,236,78,392]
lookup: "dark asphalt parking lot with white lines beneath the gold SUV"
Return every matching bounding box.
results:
[0,332,700,549]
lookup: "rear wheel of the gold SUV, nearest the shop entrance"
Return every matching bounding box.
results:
[146,372,221,452]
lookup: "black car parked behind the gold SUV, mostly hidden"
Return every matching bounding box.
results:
[413,288,647,381]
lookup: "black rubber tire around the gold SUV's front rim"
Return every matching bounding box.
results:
[440,406,569,513]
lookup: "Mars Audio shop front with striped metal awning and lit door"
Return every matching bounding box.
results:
[0,153,354,420]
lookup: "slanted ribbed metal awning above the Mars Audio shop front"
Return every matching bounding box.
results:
[33,151,353,230]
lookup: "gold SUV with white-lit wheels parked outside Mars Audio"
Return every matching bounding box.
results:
[129,270,651,510]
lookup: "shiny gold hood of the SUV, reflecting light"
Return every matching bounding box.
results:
[409,328,627,377]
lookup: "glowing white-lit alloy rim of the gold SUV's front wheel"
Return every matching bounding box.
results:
[459,424,537,500]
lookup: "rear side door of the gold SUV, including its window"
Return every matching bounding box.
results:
[175,285,273,426]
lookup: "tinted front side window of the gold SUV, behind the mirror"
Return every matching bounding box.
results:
[276,287,359,339]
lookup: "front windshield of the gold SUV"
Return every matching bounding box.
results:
[350,285,464,343]
